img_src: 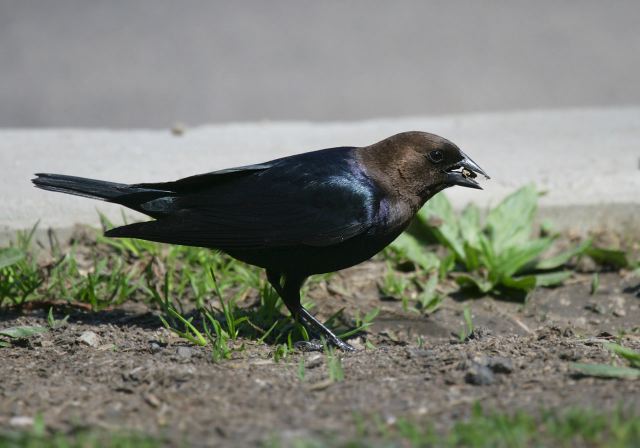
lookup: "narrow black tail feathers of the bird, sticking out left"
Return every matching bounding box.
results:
[31,173,130,202]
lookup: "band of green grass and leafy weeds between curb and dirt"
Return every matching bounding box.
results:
[0,186,640,350]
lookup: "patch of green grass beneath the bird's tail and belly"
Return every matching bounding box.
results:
[0,217,375,361]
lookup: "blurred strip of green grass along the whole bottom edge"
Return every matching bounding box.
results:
[7,404,640,448]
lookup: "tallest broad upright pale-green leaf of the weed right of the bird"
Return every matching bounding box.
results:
[487,185,538,253]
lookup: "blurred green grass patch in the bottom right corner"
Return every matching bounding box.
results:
[269,405,640,448]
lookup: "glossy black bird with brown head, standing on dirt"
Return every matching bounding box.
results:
[32,131,490,351]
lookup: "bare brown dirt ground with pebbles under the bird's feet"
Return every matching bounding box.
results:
[0,262,640,446]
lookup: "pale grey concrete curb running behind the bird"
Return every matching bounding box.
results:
[0,108,640,243]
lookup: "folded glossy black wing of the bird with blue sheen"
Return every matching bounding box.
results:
[108,154,377,249]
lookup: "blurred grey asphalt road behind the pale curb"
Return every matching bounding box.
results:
[0,0,640,128]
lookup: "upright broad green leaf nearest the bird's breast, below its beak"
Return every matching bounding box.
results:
[418,193,464,261]
